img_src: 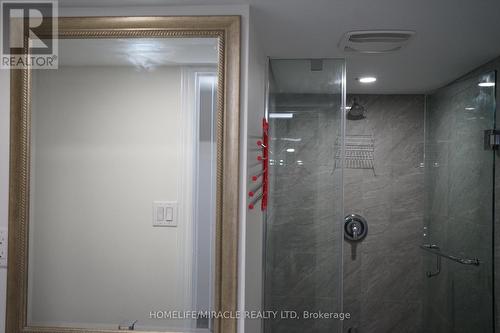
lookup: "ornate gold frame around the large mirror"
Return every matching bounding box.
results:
[6,16,240,333]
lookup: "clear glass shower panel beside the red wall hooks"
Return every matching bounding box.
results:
[264,59,345,333]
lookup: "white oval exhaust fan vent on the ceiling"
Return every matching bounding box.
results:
[339,30,415,53]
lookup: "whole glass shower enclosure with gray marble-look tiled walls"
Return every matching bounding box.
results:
[263,59,500,333]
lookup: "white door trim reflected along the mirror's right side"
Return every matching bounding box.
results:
[178,66,217,329]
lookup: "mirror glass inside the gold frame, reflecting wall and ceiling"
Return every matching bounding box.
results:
[28,38,218,331]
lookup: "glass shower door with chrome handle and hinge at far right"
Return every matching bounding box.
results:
[423,73,496,333]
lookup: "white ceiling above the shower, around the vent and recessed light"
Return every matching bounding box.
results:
[59,0,500,93]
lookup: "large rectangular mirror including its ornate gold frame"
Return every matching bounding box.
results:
[6,16,240,333]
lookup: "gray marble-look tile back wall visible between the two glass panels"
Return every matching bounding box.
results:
[343,95,425,333]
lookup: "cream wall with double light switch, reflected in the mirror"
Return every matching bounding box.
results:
[29,66,192,328]
